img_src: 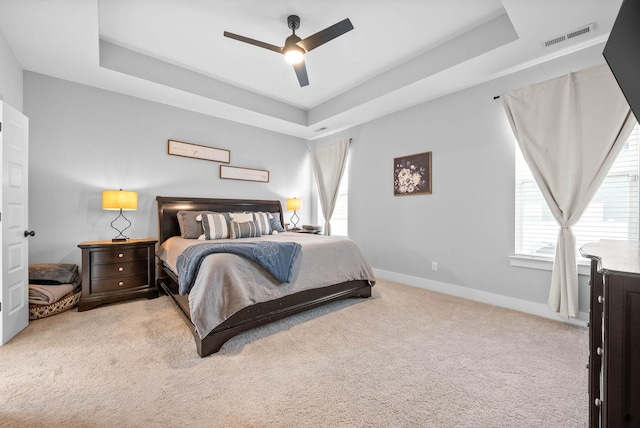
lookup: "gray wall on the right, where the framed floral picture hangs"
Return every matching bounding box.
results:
[314,46,604,315]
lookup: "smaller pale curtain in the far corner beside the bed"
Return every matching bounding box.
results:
[311,139,350,235]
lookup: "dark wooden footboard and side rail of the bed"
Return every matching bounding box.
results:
[158,272,371,357]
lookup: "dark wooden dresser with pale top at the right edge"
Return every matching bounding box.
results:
[580,240,640,428]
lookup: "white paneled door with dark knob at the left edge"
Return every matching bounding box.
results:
[0,101,29,345]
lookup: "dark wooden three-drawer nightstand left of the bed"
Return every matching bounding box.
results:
[78,238,158,312]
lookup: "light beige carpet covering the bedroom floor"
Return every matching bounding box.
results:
[0,280,588,428]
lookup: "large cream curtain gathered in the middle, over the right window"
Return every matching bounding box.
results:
[501,65,635,317]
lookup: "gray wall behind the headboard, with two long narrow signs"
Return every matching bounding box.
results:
[24,72,312,264]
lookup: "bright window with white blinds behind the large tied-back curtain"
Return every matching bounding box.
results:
[515,124,640,257]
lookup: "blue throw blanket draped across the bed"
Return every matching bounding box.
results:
[176,241,301,294]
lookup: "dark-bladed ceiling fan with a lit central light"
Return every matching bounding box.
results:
[224,15,353,87]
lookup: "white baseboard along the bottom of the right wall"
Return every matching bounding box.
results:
[373,269,589,327]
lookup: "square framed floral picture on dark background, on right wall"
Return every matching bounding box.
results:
[393,152,432,196]
